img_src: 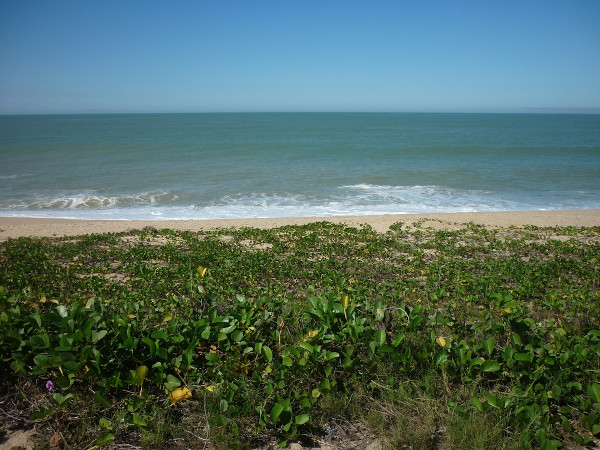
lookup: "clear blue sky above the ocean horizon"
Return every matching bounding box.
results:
[0,0,600,114]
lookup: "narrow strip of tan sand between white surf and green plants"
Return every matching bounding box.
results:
[0,209,600,241]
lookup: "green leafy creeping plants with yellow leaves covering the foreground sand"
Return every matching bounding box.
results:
[0,222,600,448]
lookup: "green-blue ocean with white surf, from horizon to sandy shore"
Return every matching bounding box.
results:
[0,113,600,220]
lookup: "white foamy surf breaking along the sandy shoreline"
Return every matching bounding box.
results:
[0,184,544,220]
